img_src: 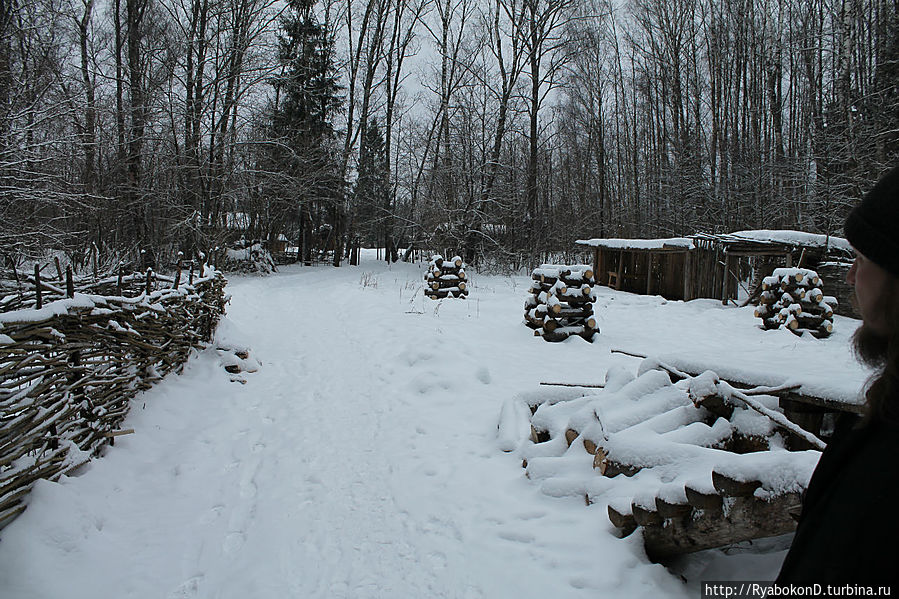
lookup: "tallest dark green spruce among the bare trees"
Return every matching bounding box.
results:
[269,0,344,266]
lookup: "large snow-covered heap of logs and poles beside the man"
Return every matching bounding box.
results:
[499,360,823,561]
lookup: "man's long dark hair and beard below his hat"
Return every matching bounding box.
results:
[852,276,899,426]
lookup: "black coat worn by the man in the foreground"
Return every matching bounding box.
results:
[777,416,899,592]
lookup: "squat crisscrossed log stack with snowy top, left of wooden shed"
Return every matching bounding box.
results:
[524,264,599,341]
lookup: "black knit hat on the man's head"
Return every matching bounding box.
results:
[843,166,899,277]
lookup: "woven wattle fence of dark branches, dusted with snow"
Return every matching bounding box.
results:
[0,265,226,528]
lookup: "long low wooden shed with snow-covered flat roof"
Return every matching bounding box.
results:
[576,230,852,308]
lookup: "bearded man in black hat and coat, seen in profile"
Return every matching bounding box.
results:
[777,167,899,592]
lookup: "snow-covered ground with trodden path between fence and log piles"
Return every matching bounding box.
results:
[0,251,865,599]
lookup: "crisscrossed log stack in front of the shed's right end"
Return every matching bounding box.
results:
[755,268,833,338]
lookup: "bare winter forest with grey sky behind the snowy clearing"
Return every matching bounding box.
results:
[0,0,899,266]
